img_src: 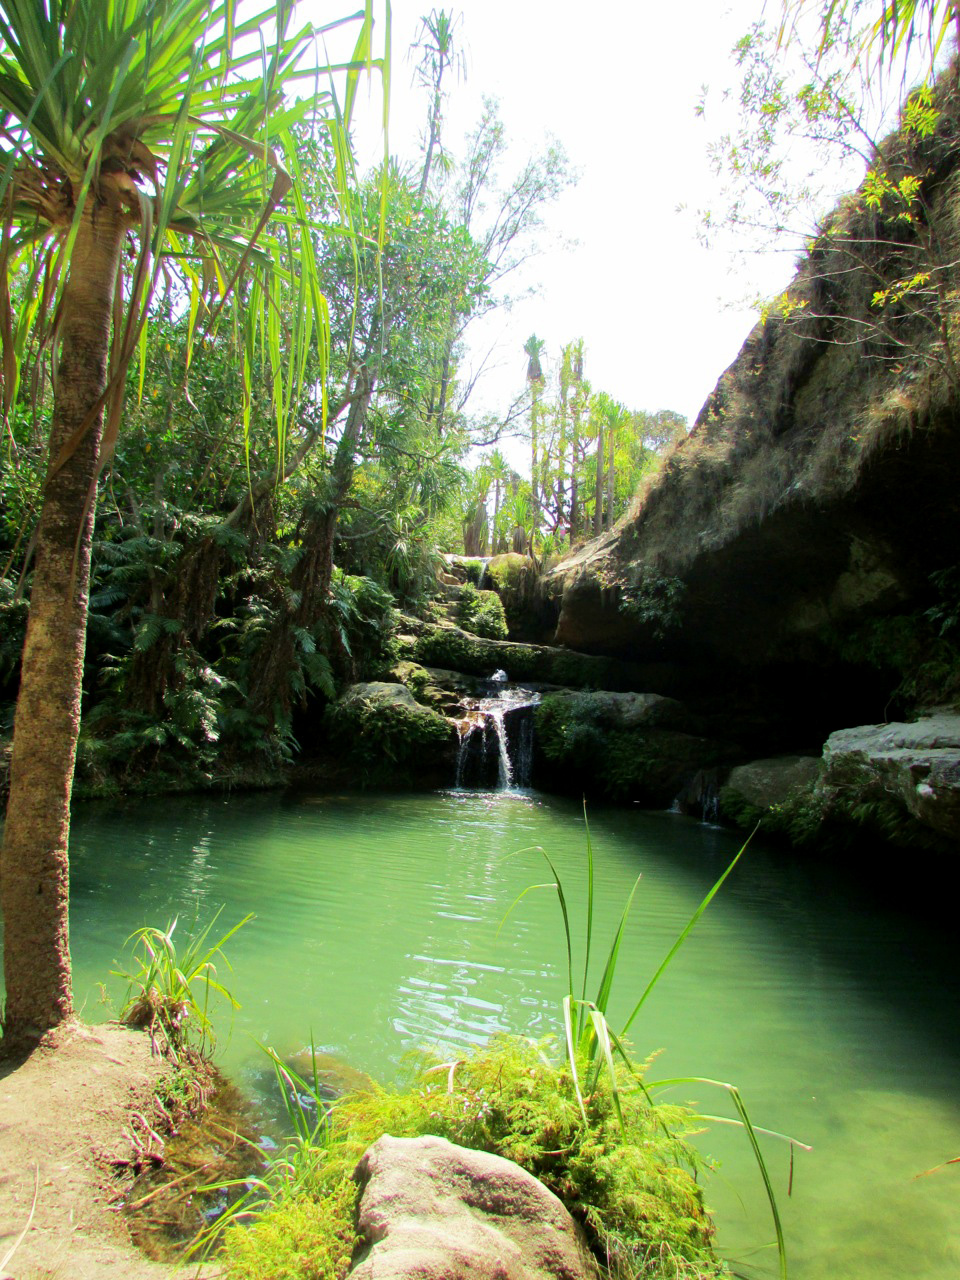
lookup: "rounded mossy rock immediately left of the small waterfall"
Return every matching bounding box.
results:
[325,681,457,786]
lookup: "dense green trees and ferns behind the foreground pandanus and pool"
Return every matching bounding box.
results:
[0,74,682,791]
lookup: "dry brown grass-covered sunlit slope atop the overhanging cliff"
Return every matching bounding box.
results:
[611,72,960,573]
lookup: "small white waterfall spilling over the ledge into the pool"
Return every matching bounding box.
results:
[454,671,540,791]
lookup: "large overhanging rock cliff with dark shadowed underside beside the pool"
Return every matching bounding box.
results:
[545,72,960,798]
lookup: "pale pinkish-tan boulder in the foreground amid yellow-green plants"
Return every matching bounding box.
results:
[349,1135,599,1280]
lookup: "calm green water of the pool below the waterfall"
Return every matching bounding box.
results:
[16,792,960,1280]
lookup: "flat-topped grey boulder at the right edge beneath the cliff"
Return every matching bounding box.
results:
[818,712,960,844]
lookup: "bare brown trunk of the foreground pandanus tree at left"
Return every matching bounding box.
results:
[0,201,123,1046]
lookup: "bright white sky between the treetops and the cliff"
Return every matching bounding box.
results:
[300,0,860,424]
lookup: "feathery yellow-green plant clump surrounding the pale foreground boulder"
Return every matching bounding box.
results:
[218,1036,726,1280]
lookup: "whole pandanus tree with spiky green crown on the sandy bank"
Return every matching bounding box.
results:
[0,0,384,1043]
